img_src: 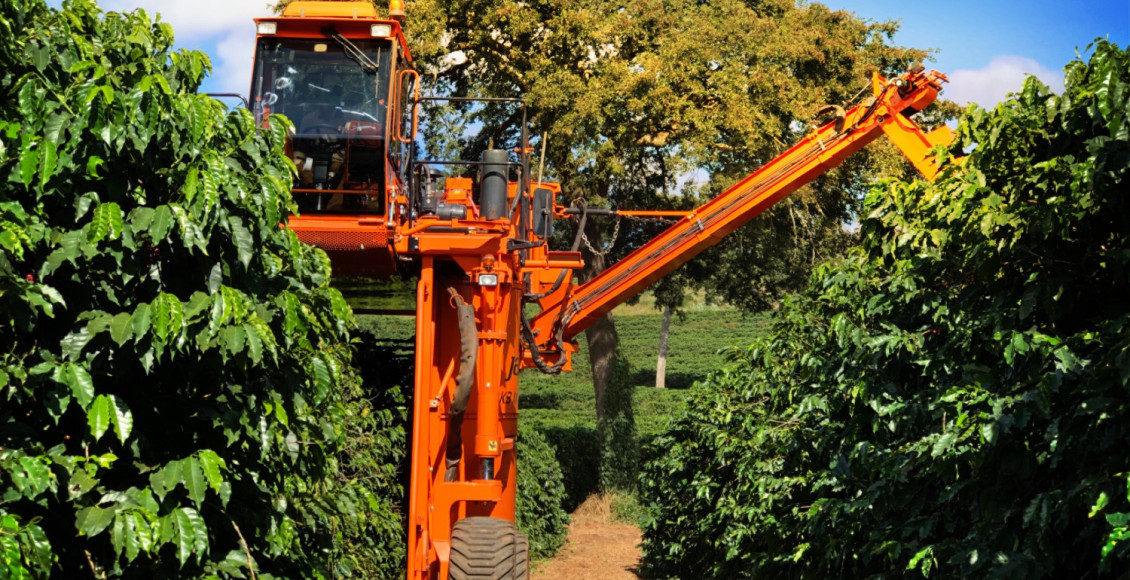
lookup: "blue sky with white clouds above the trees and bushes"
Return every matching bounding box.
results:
[51,0,1130,106]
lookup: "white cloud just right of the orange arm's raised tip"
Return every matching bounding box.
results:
[942,57,1063,107]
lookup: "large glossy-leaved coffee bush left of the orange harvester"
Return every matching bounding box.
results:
[0,0,403,579]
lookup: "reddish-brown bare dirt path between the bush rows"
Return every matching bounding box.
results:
[532,495,640,580]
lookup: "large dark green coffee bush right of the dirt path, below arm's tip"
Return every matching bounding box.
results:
[642,41,1130,579]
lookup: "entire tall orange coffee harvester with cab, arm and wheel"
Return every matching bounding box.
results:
[250,0,951,580]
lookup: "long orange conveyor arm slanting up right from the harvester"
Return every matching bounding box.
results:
[532,69,953,352]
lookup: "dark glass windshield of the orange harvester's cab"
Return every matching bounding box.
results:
[251,37,391,213]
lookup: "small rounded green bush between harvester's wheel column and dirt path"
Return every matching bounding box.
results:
[515,425,570,559]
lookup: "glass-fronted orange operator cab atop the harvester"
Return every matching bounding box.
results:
[250,1,415,275]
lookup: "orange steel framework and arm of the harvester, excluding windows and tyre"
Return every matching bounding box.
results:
[247,2,951,580]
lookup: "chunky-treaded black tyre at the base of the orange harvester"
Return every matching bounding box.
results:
[447,518,530,580]
